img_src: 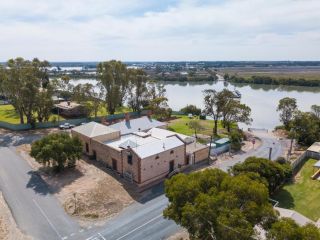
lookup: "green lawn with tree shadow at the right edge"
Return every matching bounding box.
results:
[273,159,320,221]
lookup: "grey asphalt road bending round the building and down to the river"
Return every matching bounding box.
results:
[0,132,282,240]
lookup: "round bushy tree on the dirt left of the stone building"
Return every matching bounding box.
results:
[30,133,82,171]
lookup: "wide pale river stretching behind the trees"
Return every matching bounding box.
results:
[72,79,320,129]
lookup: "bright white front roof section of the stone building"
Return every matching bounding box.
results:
[105,134,184,158]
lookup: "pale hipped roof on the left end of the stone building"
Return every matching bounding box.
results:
[72,122,119,138]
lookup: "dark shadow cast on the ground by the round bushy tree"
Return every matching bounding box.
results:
[26,167,83,195]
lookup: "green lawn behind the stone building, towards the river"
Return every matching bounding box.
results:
[168,115,236,137]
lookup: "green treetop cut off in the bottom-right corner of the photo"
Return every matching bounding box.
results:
[267,218,320,240]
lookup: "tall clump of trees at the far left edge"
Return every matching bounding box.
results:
[0,58,53,124]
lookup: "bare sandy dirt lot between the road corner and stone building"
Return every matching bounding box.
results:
[18,145,138,225]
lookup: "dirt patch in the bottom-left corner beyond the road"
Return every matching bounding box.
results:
[0,192,32,240]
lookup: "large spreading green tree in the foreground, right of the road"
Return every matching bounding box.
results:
[164,169,276,240]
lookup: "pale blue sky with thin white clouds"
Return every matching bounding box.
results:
[0,0,320,61]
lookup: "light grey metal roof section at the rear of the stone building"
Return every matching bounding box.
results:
[109,116,166,135]
